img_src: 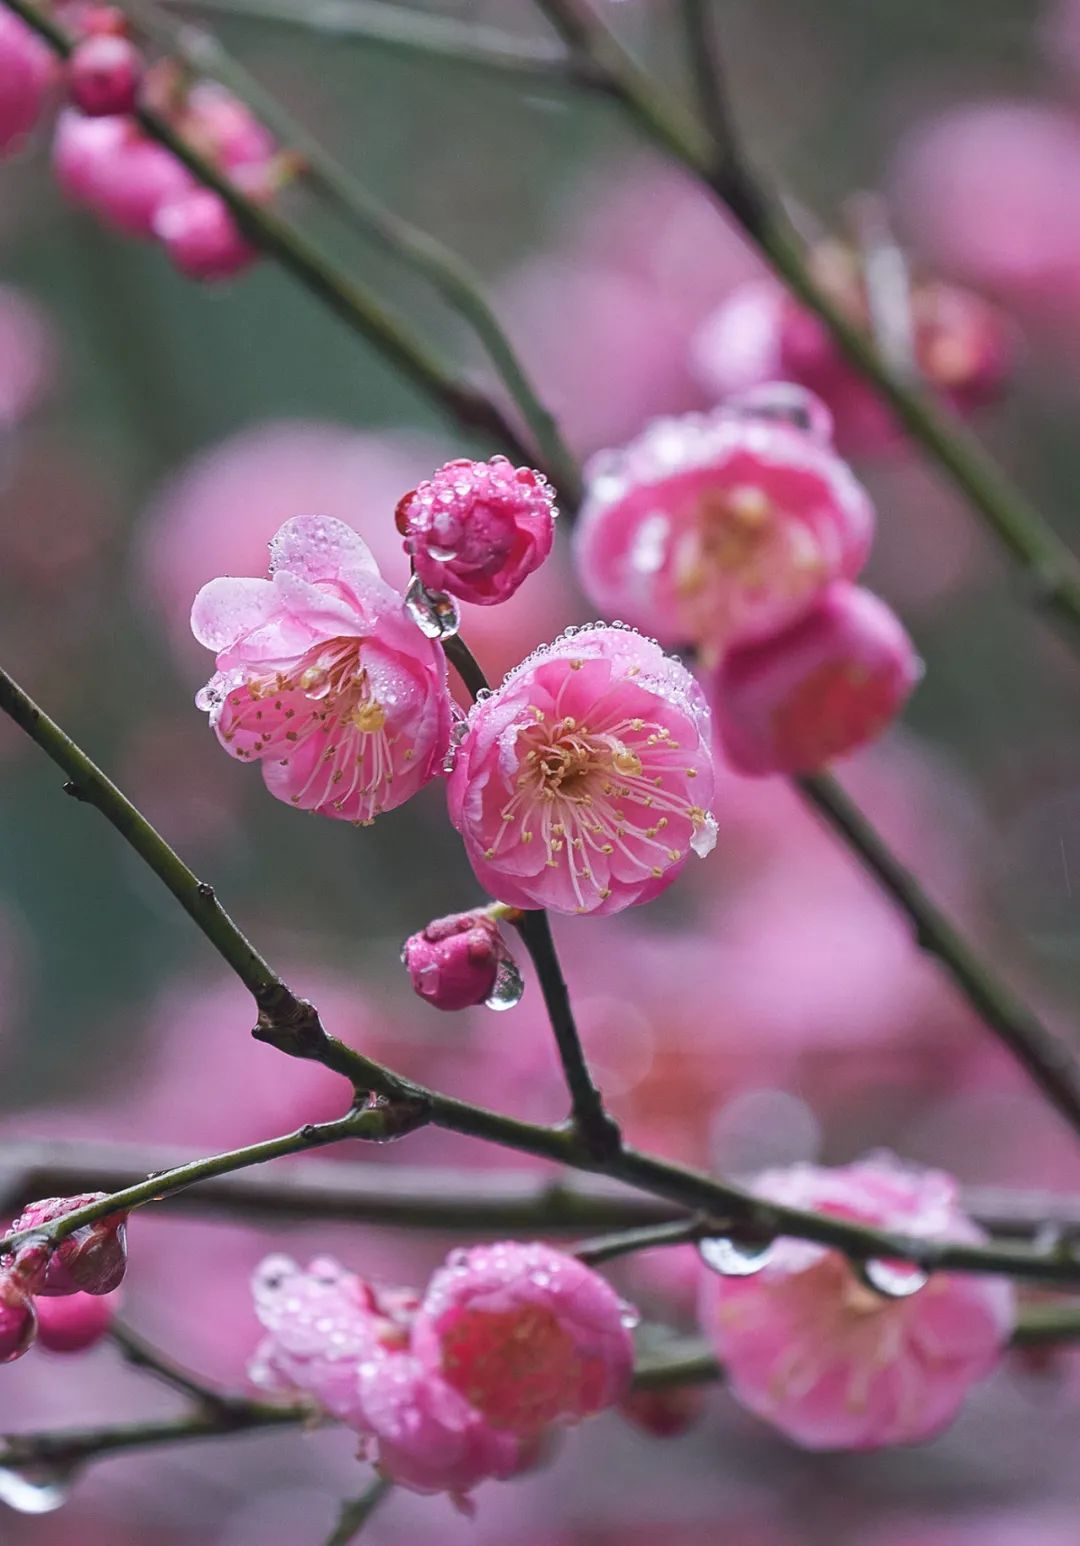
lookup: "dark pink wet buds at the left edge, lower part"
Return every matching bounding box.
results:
[0,1192,127,1364]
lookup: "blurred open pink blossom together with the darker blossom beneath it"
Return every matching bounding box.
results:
[575,383,919,775]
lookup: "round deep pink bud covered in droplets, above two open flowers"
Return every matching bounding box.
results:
[397,456,558,606]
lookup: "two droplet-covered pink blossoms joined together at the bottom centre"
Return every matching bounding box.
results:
[252,1241,637,1498]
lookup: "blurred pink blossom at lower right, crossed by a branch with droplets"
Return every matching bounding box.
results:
[700,1156,1015,1450]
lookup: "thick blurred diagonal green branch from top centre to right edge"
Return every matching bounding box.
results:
[536,0,1080,637]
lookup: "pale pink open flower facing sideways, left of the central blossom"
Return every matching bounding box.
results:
[192,516,451,826]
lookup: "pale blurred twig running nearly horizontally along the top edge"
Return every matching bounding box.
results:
[167,0,607,91]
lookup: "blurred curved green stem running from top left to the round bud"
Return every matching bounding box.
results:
[124,0,581,504]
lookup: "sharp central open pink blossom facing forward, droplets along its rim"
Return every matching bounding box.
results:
[448,623,715,914]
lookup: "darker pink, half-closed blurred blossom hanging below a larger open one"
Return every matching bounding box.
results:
[712,581,919,775]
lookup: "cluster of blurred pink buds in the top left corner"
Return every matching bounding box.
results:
[0,0,278,280]
